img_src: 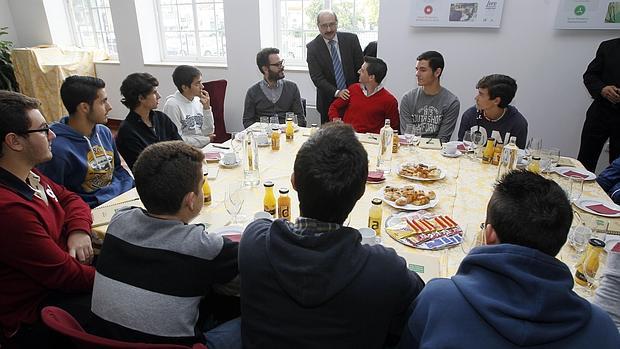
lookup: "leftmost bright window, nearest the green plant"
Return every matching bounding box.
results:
[66,0,118,59]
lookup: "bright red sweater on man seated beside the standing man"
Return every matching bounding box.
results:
[327,83,400,133]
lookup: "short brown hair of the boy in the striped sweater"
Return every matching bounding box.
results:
[133,141,204,214]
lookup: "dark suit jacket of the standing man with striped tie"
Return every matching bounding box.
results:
[306,32,364,122]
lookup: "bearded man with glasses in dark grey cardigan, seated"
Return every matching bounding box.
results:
[243,47,306,128]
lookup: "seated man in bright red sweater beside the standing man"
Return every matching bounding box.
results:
[328,56,400,133]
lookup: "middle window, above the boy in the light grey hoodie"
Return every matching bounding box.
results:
[155,0,226,63]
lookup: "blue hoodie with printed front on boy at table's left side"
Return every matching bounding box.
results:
[38,116,134,208]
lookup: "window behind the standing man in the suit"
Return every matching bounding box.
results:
[273,0,379,66]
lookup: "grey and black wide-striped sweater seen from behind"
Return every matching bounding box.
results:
[89,208,238,344]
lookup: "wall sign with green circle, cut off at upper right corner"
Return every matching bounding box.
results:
[555,0,620,29]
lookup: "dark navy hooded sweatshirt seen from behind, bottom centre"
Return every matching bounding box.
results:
[239,219,424,349]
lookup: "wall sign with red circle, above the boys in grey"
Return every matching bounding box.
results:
[410,0,504,28]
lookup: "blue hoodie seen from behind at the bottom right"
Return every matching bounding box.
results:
[400,244,620,349]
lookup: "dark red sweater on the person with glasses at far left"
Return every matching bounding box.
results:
[0,168,95,337]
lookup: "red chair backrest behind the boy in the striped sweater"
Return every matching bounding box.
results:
[41,306,207,349]
